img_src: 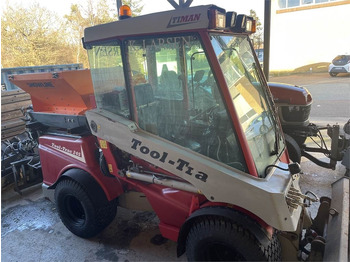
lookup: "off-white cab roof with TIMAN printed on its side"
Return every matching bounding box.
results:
[84,5,221,43]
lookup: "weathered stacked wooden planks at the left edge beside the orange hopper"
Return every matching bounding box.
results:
[1,89,32,140]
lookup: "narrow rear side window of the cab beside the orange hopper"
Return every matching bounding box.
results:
[88,42,130,118]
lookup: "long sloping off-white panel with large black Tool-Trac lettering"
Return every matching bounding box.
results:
[86,109,301,231]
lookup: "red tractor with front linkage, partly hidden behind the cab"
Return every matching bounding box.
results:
[268,83,350,172]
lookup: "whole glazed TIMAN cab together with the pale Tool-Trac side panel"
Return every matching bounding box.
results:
[83,5,303,234]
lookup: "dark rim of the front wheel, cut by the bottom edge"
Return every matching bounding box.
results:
[201,243,245,261]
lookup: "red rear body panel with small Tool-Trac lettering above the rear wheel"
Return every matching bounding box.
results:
[39,135,124,200]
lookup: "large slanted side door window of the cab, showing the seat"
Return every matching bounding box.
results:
[127,36,246,171]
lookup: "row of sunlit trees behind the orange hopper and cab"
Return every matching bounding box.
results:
[1,0,143,67]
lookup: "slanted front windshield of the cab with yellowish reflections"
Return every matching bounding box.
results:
[211,34,284,177]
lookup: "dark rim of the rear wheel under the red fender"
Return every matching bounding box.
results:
[64,196,86,226]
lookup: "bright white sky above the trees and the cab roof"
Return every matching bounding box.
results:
[1,0,265,21]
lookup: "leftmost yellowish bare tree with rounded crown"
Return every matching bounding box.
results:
[1,4,73,67]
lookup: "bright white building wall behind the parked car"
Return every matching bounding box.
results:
[270,0,350,71]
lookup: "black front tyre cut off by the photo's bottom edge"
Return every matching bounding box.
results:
[186,217,281,261]
